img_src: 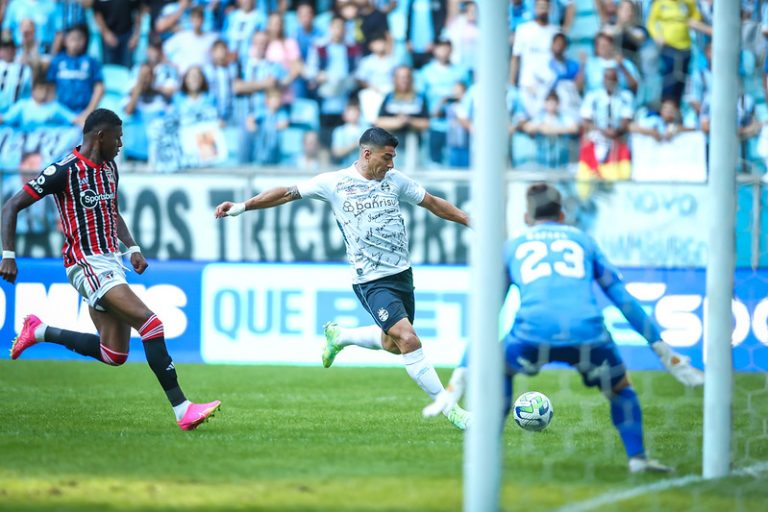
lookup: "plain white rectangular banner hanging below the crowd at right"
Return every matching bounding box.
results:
[632,131,707,182]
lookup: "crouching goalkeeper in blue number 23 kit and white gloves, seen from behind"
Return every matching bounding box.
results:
[424,183,704,473]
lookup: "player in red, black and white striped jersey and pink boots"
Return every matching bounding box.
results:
[0,109,220,430]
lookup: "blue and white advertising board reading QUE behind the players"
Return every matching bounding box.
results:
[0,259,768,372]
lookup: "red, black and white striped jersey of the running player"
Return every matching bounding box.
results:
[24,146,119,267]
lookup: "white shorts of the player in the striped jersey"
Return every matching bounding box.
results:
[67,253,128,311]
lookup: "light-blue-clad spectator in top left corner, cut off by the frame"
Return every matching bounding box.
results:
[3,0,62,55]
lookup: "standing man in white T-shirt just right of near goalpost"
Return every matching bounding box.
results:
[509,0,559,95]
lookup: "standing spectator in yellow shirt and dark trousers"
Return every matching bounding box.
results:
[647,0,712,102]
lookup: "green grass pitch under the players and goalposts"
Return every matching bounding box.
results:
[0,360,768,512]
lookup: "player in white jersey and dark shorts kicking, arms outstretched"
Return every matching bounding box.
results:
[216,128,469,430]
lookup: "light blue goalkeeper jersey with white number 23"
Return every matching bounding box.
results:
[504,222,623,346]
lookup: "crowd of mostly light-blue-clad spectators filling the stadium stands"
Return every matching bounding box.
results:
[0,0,768,172]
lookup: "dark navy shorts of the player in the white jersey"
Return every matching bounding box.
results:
[352,268,416,332]
